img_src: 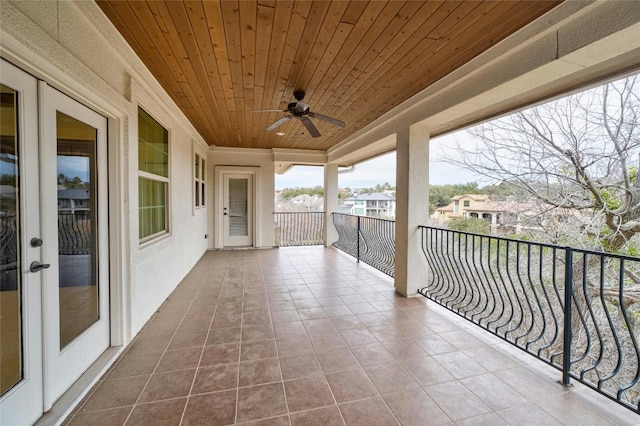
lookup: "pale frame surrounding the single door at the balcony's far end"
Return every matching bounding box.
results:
[214,166,261,249]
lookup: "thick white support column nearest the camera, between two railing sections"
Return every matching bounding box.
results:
[395,125,429,296]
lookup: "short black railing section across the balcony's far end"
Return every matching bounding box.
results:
[273,212,324,247]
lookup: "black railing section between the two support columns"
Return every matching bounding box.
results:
[332,213,396,277]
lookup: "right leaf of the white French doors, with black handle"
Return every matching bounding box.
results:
[40,83,110,410]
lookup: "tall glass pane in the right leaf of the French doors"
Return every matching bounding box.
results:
[56,112,100,349]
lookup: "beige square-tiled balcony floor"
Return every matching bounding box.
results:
[65,247,640,426]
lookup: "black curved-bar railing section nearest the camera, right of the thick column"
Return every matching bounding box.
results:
[420,226,640,412]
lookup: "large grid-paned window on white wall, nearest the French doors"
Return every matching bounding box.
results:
[138,108,169,242]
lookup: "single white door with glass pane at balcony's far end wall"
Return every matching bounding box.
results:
[222,174,253,247]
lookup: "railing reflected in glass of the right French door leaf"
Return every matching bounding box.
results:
[58,211,91,255]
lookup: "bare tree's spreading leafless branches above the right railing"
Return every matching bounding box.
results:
[442,76,640,252]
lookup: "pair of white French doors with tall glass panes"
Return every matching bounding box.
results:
[0,60,110,425]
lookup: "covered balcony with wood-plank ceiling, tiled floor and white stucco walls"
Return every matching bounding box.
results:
[0,0,640,426]
